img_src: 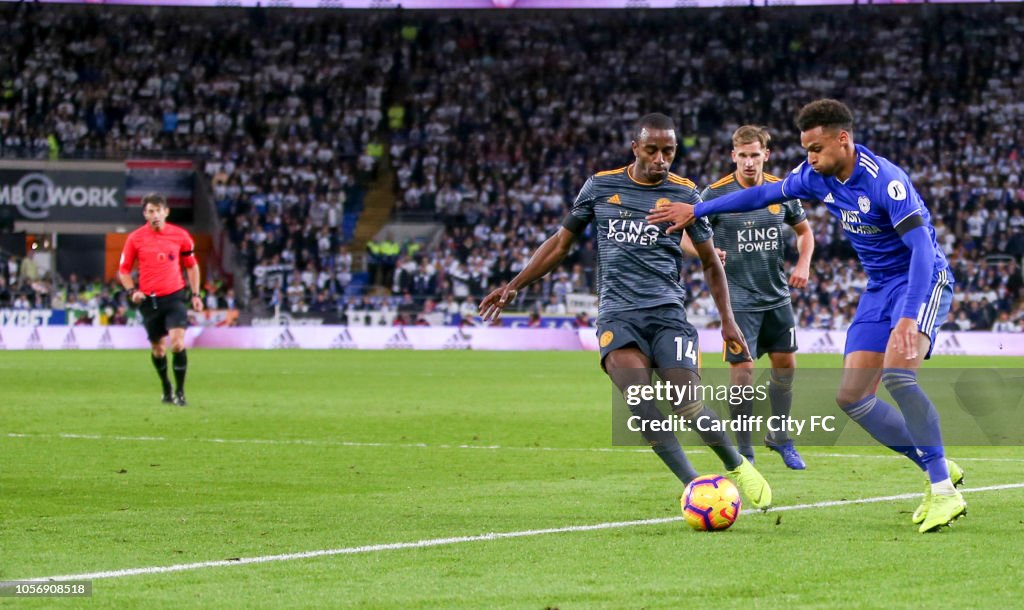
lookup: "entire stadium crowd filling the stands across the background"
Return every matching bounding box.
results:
[0,3,1024,330]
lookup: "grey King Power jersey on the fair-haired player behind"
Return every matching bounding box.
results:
[700,173,807,311]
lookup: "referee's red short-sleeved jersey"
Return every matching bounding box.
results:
[119,222,197,297]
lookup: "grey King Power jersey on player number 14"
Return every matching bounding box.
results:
[562,167,712,314]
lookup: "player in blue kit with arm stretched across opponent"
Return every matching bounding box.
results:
[647,99,967,533]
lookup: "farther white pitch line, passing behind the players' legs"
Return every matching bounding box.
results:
[5,432,1024,463]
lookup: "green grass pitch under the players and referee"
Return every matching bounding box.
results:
[0,350,1024,609]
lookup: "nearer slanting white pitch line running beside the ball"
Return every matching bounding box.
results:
[9,483,1024,586]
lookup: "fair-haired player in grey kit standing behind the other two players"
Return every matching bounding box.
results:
[683,125,814,470]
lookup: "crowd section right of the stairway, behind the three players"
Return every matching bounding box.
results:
[378,3,1024,329]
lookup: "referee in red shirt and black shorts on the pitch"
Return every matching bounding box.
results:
[118,193,203,406]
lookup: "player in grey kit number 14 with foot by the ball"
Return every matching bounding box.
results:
[480,114,772,509]
